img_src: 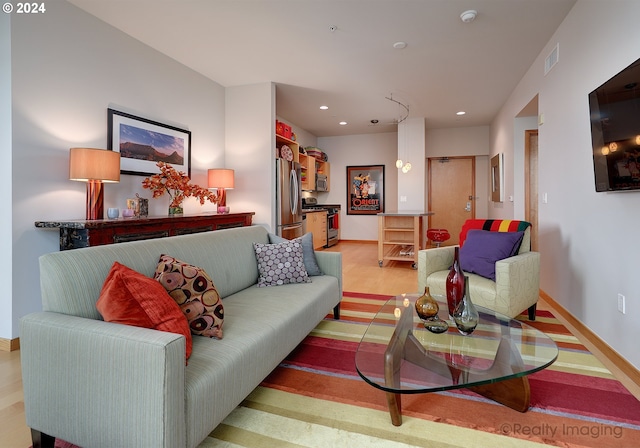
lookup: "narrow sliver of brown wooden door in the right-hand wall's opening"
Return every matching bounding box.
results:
[524,129,538,252]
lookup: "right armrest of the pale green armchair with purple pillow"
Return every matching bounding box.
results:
[496,252,540,316]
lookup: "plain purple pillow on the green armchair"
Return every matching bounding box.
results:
[460,230,524,281]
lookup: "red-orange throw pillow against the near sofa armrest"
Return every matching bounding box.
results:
[96,261,193,359]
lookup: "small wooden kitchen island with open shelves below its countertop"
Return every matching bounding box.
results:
[378,212,433,269]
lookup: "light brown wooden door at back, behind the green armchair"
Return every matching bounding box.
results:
[428,157,475,246]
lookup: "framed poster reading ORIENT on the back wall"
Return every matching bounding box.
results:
[347,165,384,215]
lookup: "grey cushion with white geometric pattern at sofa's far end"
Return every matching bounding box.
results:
[253,239,311,287]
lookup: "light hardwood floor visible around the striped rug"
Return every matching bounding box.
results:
[0,241,640,448]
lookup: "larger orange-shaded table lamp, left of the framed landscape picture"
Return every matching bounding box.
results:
[69,148,120,220]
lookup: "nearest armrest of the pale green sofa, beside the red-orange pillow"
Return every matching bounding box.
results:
[20,312,186,447]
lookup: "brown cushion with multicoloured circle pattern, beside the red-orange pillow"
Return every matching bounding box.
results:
[154,254,224,339]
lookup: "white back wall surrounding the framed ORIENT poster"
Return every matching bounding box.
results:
[318,132,398,241]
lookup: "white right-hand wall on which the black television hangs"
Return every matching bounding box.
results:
[491,0,640,368]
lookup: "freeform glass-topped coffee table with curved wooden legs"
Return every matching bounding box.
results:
[356,294,558,426]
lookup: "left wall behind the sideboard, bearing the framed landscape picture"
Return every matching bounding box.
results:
[0,2,225,339]
